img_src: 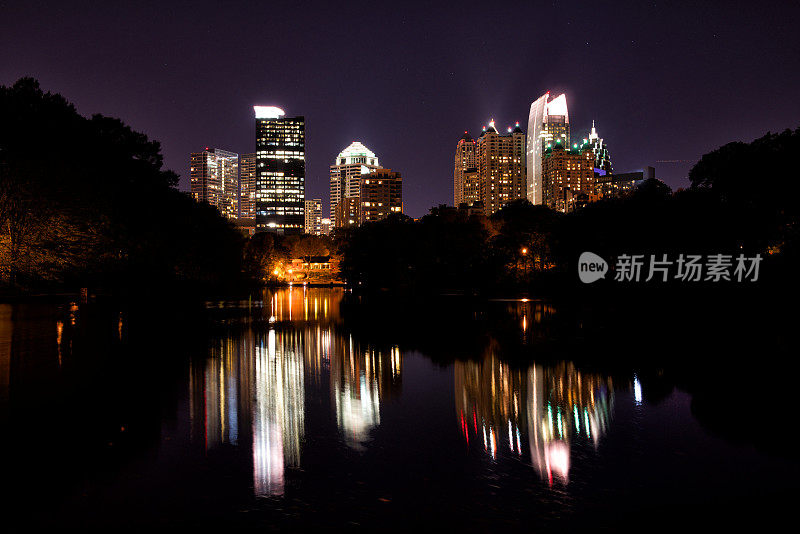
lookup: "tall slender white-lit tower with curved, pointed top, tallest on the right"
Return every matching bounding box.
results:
[526,93,570,204]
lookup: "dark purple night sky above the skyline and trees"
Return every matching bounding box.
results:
[0,0,800,216]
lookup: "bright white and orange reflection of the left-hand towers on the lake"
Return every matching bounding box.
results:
[190,286,401,495]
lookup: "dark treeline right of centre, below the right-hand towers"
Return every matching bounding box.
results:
[342,129,800,294]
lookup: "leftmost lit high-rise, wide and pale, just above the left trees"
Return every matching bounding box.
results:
[189,147,239,219]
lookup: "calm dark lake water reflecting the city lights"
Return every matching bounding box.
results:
[0,287,800,531]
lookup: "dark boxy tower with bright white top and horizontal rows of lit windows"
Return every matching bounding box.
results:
[253,106,306,234]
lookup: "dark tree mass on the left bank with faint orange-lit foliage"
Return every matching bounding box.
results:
[0,78,242,296]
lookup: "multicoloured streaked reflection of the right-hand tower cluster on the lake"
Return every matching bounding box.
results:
[455,353,614,484]
